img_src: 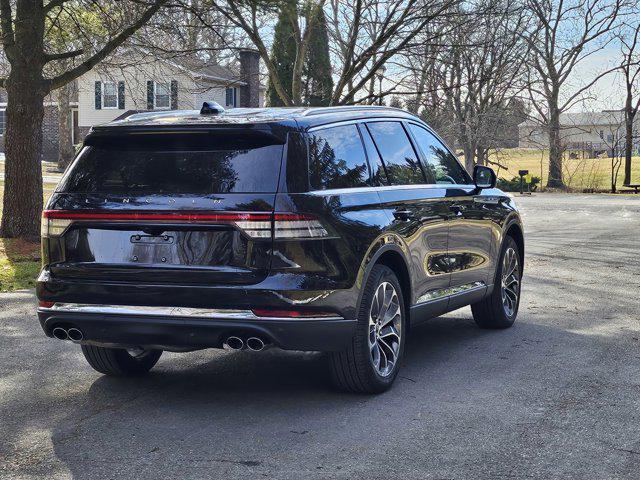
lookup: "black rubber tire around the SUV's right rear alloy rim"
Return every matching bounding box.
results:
[330,265,407,393]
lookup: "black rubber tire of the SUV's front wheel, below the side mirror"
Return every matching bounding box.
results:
[471,236,522,329]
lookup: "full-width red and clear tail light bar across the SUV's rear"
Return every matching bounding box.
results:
[42,210,329,239]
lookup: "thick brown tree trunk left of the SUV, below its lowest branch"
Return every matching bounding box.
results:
[0,81,45,240]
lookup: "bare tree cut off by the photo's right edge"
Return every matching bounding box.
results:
[620,22,640,185]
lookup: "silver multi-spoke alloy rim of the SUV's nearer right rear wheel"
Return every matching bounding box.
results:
[369,282,402,377]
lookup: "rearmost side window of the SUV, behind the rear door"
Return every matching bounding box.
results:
[309,125,369,190]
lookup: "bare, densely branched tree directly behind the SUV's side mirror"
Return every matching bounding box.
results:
[403,0,527,171]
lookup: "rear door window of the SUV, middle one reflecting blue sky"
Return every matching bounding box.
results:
[367,122,425,185]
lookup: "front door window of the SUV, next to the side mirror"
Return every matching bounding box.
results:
[409,123,471,185]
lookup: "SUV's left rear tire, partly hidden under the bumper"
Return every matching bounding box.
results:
[81,345,162,377]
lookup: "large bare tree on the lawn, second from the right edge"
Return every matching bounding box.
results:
[522,0,628,188]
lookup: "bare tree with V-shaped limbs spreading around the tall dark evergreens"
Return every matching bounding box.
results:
[202,0,460,105]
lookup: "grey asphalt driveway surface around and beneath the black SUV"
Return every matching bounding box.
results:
[0,195,640,479]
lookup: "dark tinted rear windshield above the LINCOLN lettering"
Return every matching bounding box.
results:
[58,134,283,196]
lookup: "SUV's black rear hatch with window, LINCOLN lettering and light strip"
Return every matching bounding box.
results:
[43,130,283,285]
